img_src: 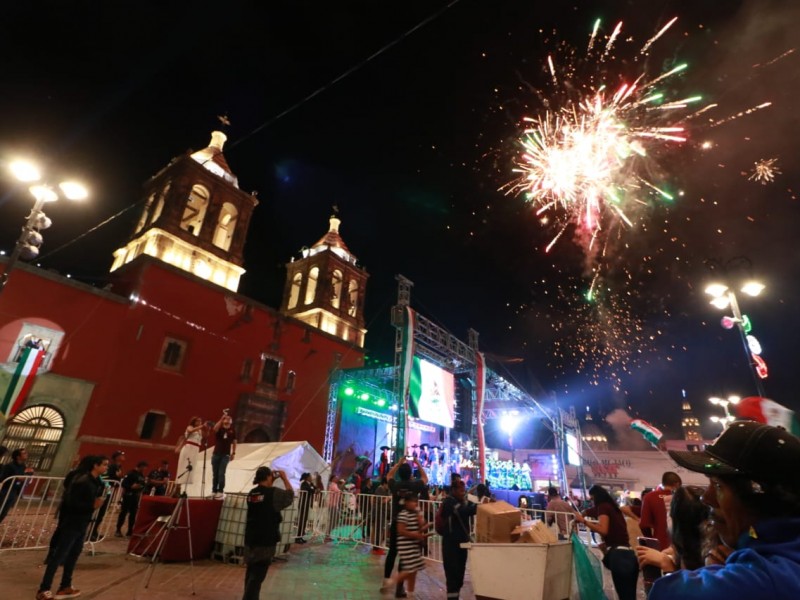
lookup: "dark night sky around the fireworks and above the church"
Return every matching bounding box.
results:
[0,0,800,448]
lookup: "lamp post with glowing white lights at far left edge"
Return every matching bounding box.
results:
[0,160,89,293]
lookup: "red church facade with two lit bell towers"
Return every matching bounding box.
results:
[0,130,367,474]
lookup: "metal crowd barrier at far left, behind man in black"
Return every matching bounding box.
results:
[0,475,122,554]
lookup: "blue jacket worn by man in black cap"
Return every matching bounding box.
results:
[648,518,800,600]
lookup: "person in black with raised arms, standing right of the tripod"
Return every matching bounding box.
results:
[242,467,294,600]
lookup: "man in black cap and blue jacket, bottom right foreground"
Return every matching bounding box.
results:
[649,421,800,600]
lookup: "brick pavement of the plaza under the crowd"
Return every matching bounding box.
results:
[0,539,475,600]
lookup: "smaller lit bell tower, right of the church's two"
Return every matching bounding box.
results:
[281,214,369,348]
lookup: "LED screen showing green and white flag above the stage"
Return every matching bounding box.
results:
[409,356,456,428]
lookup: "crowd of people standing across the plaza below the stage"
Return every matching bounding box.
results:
[0,414,800,600]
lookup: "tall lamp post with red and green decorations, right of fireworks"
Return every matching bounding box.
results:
[705,256,768,398]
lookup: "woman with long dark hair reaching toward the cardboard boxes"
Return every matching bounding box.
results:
[575,485,639,600]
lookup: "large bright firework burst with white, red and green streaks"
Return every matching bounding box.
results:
[505,18,708,251]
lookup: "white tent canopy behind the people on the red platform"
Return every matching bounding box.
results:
[185,442,330,497]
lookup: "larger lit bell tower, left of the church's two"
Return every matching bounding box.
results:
[111,131,258,292]
